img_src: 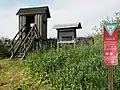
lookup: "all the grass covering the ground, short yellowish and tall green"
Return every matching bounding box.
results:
[0,35,120,90]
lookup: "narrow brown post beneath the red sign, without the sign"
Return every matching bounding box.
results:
[108,66,114,90]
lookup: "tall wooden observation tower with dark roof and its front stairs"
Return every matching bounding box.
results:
[10,6,51,59]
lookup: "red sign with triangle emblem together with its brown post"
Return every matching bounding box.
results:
[103,23,118,90]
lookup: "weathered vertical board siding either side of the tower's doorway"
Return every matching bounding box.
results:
[19,14,47,39]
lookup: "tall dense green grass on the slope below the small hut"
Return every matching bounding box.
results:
[15,35,120,90]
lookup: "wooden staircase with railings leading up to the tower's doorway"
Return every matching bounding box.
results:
[9,24,40,59]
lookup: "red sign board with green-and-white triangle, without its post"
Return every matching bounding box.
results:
[104,24,118,66]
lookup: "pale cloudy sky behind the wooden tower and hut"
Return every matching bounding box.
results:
[0,0,120,38]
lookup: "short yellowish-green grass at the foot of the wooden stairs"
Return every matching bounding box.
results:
[0,59,50,90]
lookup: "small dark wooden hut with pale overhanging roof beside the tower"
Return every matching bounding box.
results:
[53,22,82,43]
